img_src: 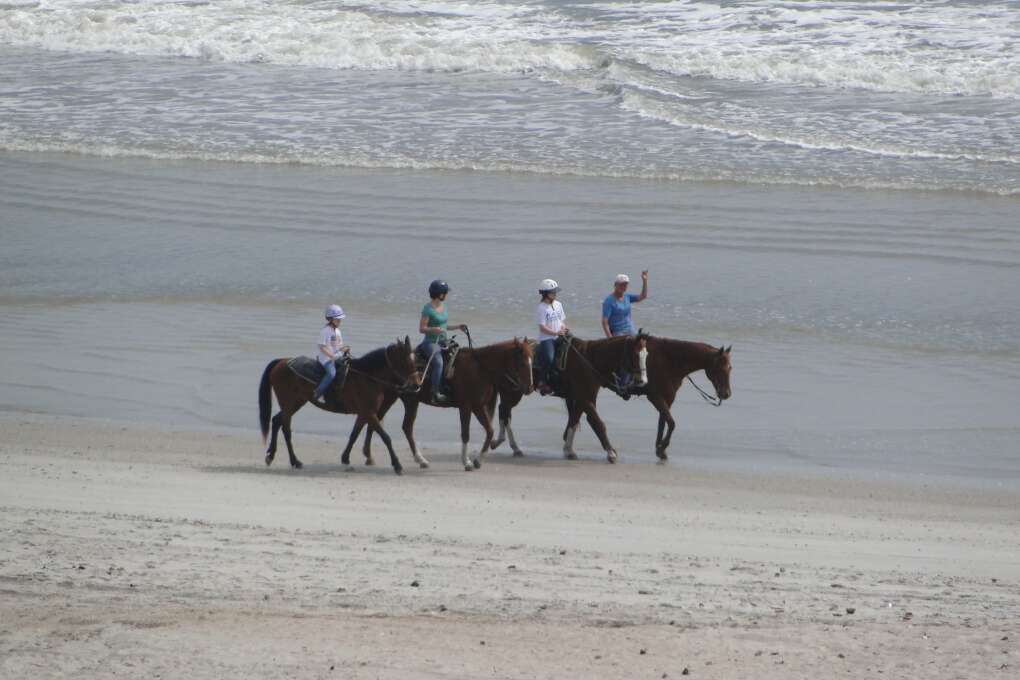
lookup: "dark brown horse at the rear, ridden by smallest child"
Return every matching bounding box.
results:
[258,337,425,474]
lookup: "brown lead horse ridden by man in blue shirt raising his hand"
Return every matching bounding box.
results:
[647,337,733,461]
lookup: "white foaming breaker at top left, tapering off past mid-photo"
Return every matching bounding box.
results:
[0,0,602,72]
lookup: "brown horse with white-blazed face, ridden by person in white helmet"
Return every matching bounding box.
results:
[489,332,652,463]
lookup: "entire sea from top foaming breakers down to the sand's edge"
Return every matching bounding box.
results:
[0,0,1020,485]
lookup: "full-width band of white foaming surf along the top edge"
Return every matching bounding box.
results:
[0,0,1020,99]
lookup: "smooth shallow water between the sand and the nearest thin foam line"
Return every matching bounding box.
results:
[0,154,1020,485]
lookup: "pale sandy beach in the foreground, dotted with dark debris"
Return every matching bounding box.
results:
[0,413,1020,680]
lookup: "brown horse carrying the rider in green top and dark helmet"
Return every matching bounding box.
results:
[354,337,534,470]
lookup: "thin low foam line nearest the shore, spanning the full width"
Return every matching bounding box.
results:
[0,136,1020,197]
